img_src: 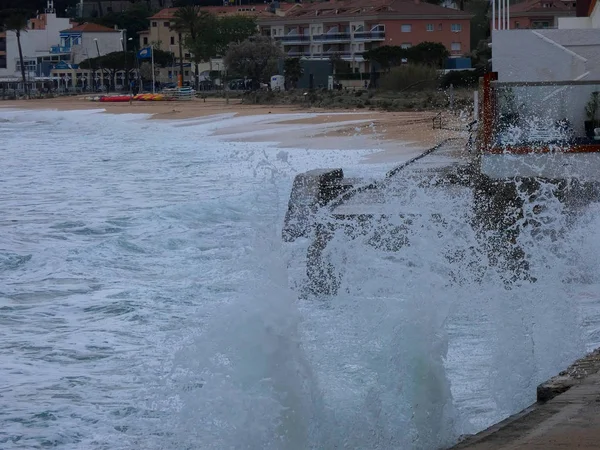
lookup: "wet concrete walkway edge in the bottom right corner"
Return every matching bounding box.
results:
[452,349,600,450]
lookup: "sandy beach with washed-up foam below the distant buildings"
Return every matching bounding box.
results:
[0,97,468,163]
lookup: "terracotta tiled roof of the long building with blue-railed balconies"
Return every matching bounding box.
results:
[258,0,471,21]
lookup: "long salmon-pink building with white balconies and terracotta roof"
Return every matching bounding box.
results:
[259,0,472,72]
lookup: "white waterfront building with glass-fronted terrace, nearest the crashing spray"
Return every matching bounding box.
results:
[481,0,600,182]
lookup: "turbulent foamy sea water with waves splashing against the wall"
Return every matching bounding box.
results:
[0,109,600,450]
